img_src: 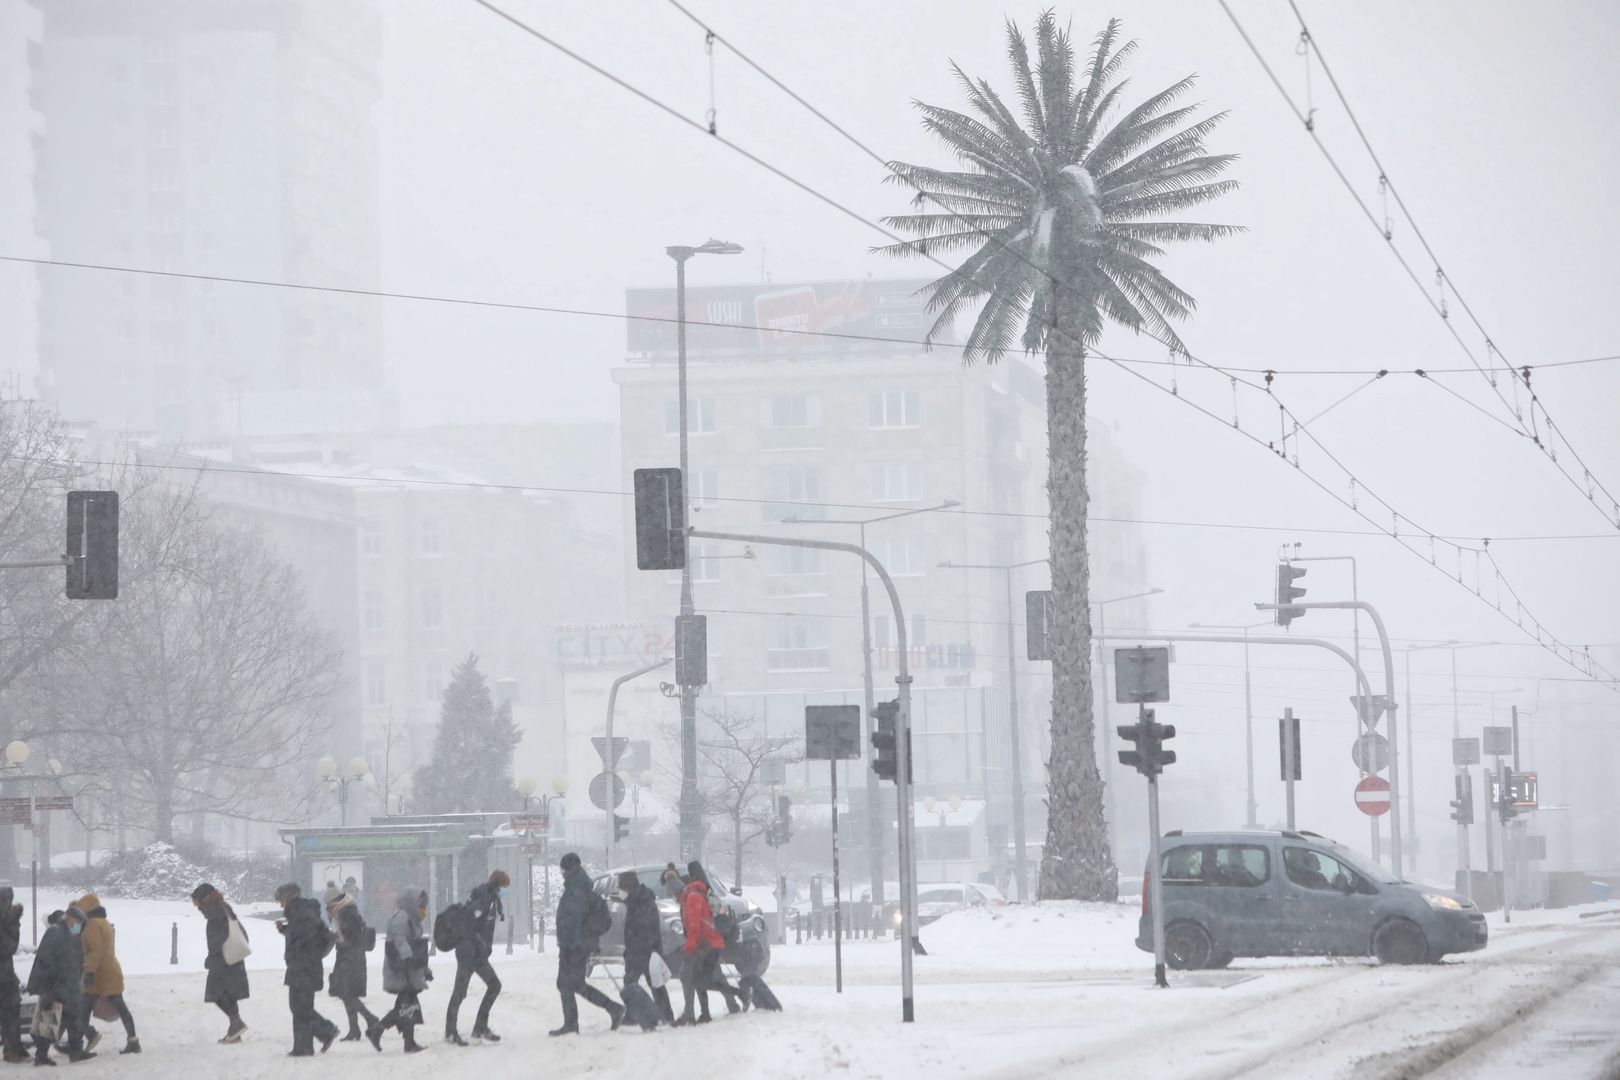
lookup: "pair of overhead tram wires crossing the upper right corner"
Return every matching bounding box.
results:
[1220,0,1620,529]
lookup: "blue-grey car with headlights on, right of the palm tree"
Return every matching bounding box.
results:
[1136,831,1487,970]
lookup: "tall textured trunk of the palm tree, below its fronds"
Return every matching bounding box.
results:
[1040,288,1119,900]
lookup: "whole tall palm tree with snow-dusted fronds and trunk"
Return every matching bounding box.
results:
[880,11,1238,900]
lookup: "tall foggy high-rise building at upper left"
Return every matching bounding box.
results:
[28,0,390,442]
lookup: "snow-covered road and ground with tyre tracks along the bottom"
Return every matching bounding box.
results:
[25,905,1620,1080]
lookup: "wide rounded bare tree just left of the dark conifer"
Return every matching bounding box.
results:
[38,489,340,840]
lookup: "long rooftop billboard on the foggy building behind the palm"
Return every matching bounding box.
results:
[625,279,933,356]
